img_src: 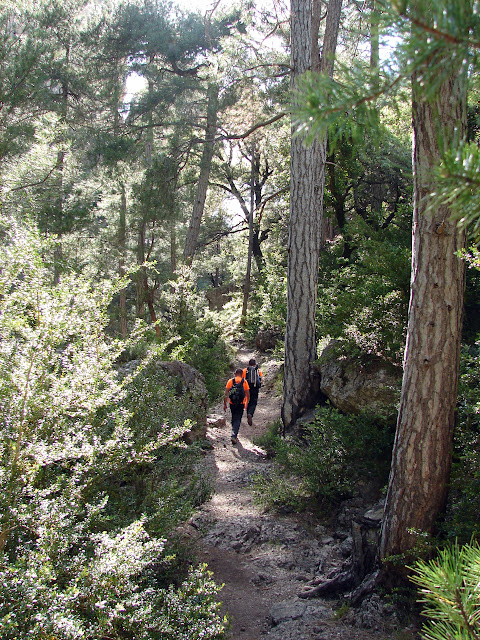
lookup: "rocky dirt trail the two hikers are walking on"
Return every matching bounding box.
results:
[190,349,411,640]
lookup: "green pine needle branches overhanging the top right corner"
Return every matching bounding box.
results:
[293,0,480,244]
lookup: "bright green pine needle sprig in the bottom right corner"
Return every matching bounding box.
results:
[412,543,480,640]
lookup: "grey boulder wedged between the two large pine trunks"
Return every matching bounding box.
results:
[317,340,403,413]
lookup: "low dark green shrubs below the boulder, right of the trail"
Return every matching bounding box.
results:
[254,406,395,511]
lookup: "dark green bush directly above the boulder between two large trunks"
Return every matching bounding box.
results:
[317,216,410,363]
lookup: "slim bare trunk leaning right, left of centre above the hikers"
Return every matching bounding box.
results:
[183,84,218,264]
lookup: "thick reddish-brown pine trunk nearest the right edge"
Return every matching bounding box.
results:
[380,70,466,559]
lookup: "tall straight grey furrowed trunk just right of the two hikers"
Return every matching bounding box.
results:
[282,0,342,436]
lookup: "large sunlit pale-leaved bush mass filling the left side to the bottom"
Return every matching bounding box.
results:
[0,218,225,640]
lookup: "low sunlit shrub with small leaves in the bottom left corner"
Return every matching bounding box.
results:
[0,536,226,640]
